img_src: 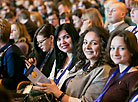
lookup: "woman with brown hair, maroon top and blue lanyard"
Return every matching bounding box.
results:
[95,31,138,102]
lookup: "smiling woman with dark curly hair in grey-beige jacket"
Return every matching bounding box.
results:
[34,27,110,102]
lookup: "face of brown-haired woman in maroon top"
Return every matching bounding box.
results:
[110,36,132,65]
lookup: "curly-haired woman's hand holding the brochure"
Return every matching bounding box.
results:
[33,79,62,97]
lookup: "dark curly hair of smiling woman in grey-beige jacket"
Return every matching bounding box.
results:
[77,26,109,70]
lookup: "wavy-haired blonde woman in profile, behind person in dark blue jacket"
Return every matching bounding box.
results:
[10,22,31,55]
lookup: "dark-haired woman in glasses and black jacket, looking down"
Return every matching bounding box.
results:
[27,24,55,77]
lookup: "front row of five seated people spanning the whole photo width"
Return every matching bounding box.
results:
[0,19,138,102]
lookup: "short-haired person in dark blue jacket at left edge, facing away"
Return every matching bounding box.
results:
[0,19,25,90]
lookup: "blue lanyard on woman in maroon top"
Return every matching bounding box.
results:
[93,65,131,102]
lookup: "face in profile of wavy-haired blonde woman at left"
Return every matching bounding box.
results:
[10,24,20,39]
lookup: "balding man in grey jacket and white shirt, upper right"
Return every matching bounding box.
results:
[106,2,129,34]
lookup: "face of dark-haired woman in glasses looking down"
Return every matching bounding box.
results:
[36,35,53,52]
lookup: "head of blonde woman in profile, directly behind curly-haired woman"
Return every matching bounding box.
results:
[79,8,104,35]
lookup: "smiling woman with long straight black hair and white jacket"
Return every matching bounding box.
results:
[50,23,79,88]
